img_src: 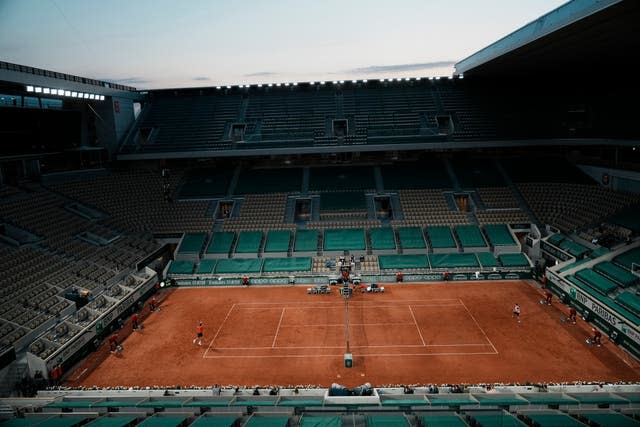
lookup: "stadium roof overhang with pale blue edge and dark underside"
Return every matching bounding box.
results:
[454,0,640,77]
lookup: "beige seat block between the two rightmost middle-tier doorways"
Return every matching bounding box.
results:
[394,189,469,226]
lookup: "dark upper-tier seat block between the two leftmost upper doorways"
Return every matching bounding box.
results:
[131,94,242,152]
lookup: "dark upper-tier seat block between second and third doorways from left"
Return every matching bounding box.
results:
[245,88,336,141]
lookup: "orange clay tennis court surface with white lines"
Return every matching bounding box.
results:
[67,281,640,387]
